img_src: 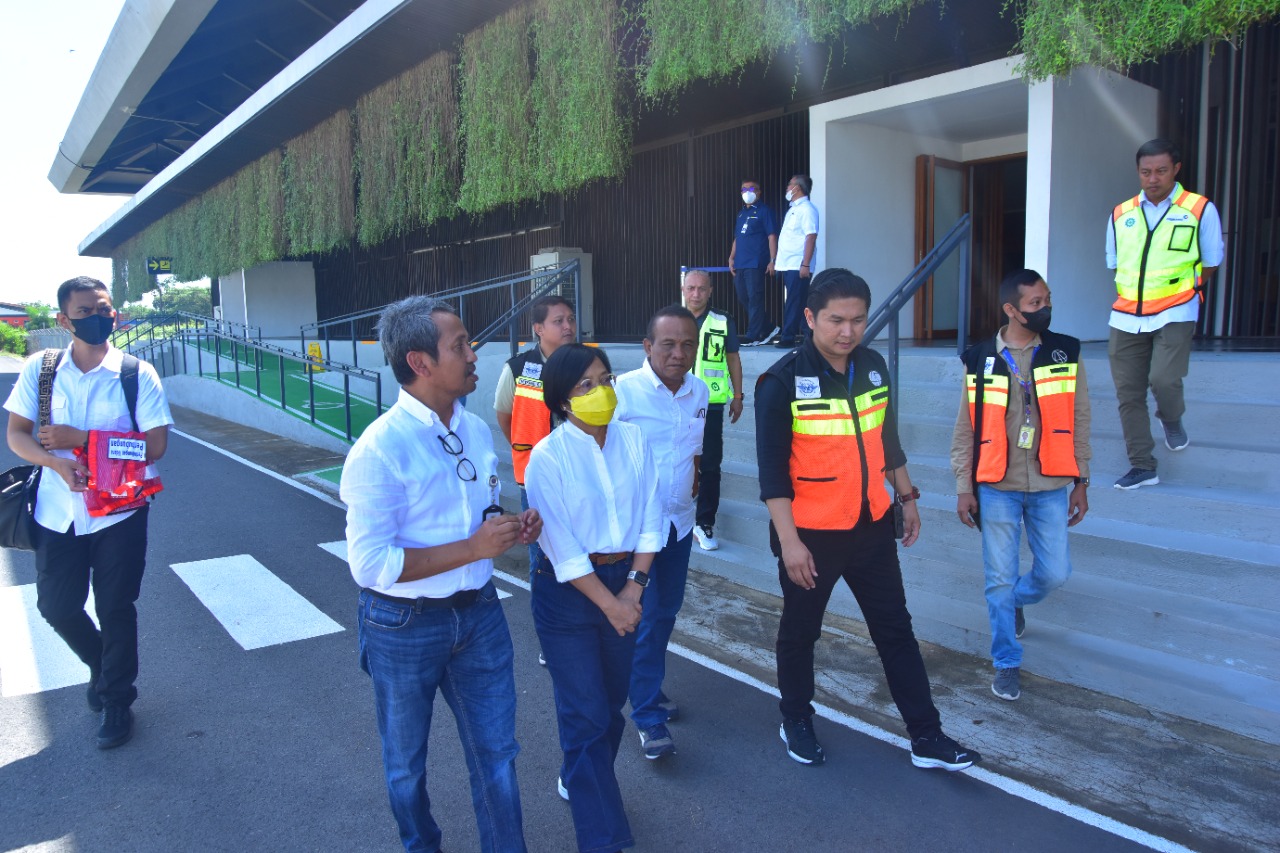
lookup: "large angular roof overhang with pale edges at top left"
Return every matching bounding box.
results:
[67,0,515,257]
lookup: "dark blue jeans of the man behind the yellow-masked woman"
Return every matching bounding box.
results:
[631,528,694,729]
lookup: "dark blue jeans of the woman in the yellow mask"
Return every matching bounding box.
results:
[534,556,636,853]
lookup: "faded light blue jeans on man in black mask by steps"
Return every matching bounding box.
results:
[978,483,1071,670]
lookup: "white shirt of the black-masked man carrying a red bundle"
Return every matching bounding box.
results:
[4,346,173,537]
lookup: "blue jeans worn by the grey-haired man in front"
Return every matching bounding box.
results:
[358,581,525,853]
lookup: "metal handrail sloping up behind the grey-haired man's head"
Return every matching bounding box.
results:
[298,259,582,365]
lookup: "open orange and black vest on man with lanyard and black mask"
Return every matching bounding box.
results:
[961,332,1080,483]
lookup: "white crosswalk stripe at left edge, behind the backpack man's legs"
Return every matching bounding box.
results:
[0,584,97,695]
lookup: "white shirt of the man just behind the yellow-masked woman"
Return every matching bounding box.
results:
[613,359,710,544]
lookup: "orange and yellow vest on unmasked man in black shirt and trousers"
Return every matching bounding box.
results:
[765,339,896,530]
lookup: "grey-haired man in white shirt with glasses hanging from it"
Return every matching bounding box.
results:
[342,296,541,852]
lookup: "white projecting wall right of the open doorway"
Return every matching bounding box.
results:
[1027,68,1158,341]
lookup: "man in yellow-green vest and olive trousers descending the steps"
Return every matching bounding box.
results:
[1106,140,1224,491]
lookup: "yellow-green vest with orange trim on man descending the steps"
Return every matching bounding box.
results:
[1111,183,1208,316]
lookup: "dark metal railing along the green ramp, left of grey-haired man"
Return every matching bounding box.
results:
[137,329,383,441]
